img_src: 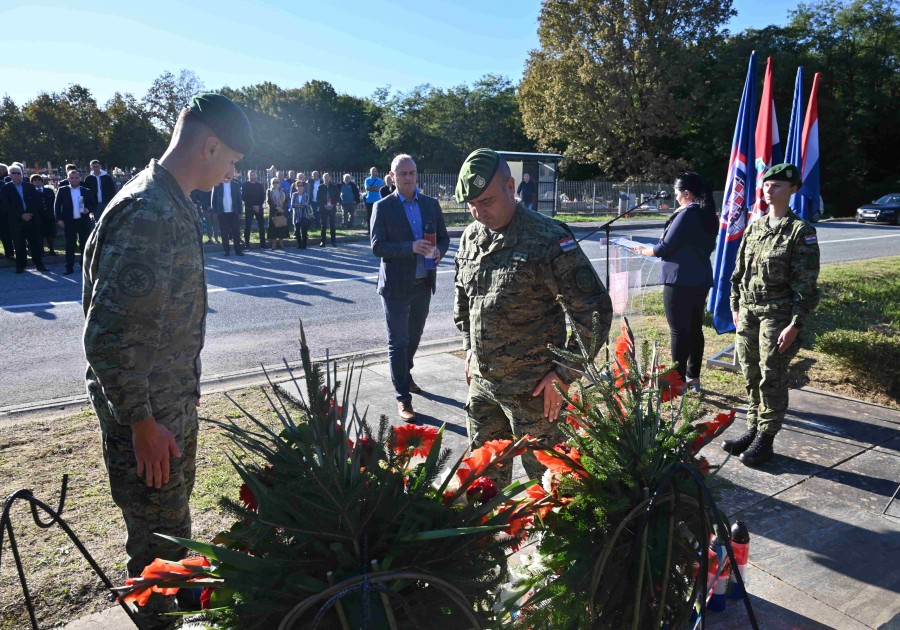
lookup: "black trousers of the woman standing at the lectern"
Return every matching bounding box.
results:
[663,284,709,380]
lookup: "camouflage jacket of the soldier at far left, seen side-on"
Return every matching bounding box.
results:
[82,160,207,424]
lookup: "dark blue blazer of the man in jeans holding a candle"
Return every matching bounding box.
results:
[370,191,450,298]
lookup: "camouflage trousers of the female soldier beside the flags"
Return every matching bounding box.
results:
[735,306,801,435]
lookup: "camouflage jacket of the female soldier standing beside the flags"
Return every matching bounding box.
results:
[731,212,819,327]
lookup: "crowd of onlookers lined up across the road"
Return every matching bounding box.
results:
[0,160,396,275]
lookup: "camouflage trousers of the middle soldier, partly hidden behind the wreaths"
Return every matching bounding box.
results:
[466,377,565,488]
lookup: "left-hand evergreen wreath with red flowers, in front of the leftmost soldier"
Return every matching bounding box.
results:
[123,332,540,628]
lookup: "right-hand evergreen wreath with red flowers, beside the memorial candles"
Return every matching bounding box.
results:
[521,320,712,630]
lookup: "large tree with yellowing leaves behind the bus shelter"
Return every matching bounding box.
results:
[519,0,734,179]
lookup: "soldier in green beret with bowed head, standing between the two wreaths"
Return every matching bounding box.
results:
[453,149,612,487]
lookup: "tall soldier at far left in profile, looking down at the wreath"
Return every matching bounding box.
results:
[82,94,253,628]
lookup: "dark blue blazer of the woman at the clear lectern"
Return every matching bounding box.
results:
[653,204,718,288]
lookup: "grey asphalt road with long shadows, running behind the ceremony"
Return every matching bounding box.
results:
[0,223,900,410]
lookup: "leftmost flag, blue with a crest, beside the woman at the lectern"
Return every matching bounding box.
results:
[706,51,756,334]
